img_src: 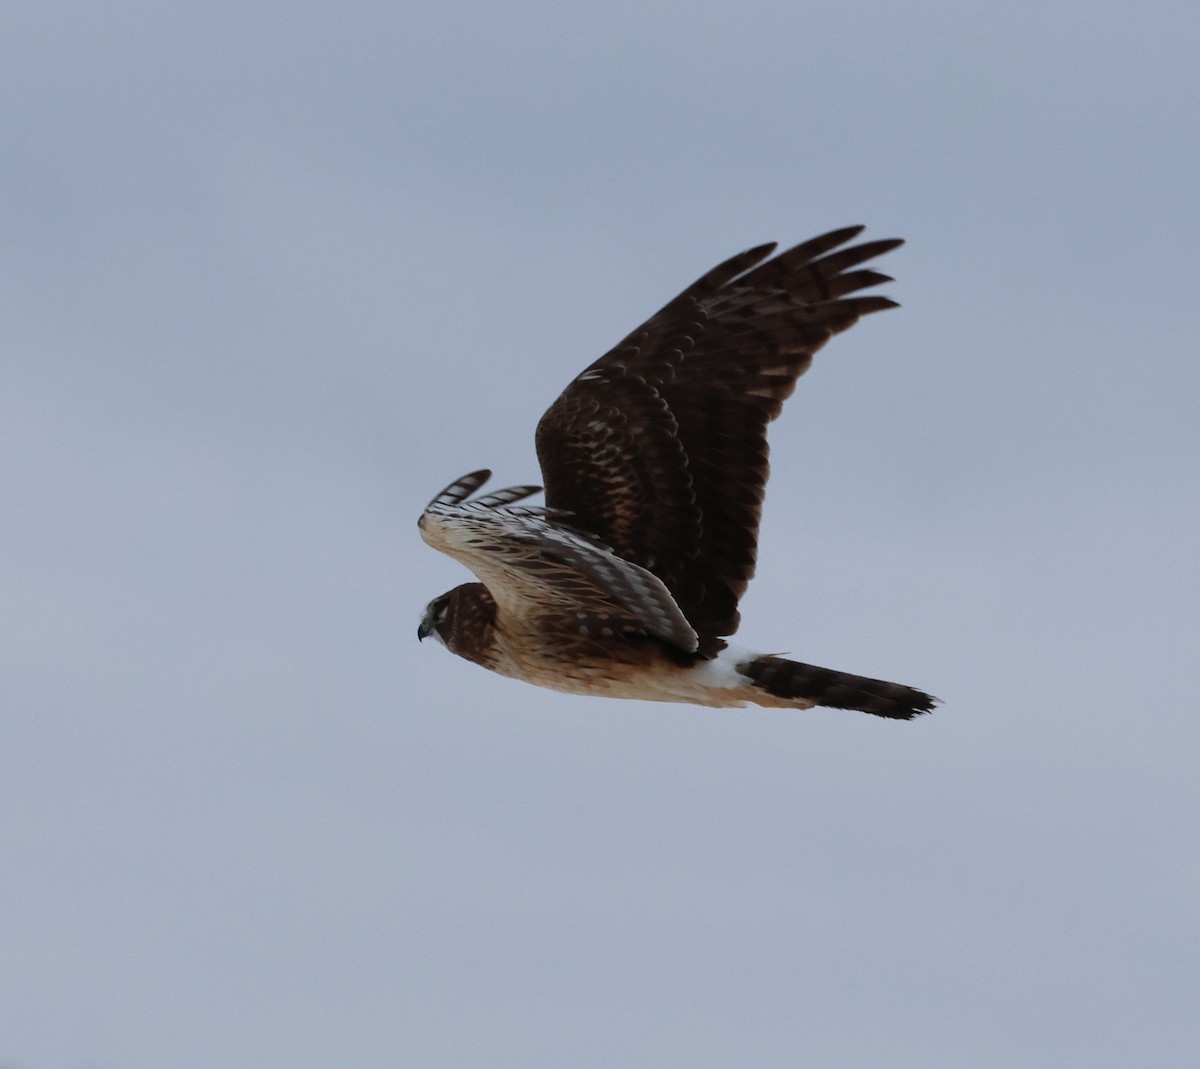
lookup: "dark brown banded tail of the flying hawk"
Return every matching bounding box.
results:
[737,654,937,720]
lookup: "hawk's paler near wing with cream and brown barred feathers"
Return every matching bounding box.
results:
[418,472,697,653]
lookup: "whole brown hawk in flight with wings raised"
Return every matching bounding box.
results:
[418,227,937,720]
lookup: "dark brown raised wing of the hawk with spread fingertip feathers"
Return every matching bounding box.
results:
[538,227,902,653]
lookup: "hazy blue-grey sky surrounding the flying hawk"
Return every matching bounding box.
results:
[0,0,1200,1069]
